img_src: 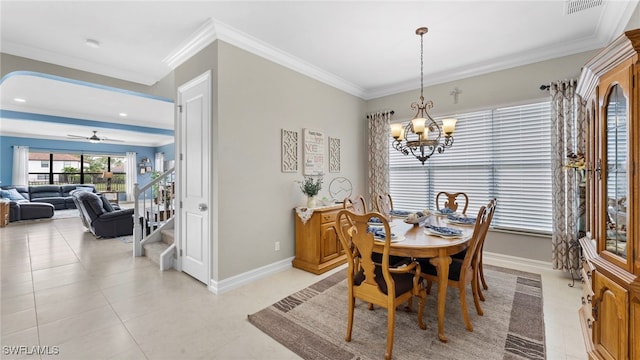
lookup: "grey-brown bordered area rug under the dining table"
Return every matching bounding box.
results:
[249,265,545,360]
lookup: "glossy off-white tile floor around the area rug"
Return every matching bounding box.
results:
[0,215,586,360]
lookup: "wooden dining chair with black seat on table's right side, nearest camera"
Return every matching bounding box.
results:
[418,200,495,331]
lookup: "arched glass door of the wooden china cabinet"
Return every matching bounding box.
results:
[604,85,629,259]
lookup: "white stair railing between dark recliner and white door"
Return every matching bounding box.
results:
[133,168,175,256]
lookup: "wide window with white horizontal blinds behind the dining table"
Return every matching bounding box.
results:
[389,102,552,233]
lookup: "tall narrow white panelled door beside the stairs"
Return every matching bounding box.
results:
[178,72,211,285]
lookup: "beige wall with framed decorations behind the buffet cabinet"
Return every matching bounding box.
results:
[175,41,366,281]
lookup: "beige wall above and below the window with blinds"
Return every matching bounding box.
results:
[367,51,596,262]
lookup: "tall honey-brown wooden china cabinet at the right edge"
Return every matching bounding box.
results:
[578,29,640,359]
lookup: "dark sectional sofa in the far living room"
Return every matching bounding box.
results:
[0,184,96,222]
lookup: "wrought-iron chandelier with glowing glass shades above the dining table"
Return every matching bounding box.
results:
[391,27,456,165]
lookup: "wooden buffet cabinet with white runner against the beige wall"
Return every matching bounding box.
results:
[292,204,347,274]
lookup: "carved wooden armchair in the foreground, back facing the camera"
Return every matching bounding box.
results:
[336,210,427,359]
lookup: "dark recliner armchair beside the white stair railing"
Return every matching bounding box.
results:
[71,190,133,238]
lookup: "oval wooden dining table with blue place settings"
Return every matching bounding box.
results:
[373,214,475,342]
